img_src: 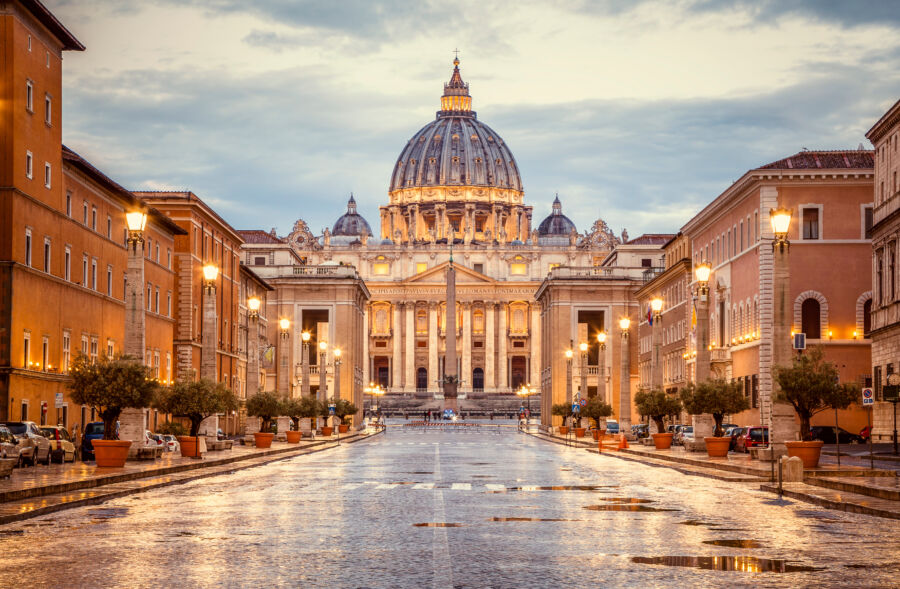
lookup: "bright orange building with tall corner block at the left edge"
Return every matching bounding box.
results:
[0,1,181,426]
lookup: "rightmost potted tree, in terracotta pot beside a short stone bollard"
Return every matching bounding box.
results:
[775,346,856,468]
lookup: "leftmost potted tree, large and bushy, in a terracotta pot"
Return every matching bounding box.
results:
[69,354,157,468]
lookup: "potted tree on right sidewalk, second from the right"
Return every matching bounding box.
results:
[681,379,750,458]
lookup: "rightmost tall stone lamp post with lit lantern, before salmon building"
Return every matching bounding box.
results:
[764,207,794,464]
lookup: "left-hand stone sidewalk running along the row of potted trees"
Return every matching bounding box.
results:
[0,432,380,525]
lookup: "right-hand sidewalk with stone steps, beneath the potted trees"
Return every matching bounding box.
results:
[529,432,900,519]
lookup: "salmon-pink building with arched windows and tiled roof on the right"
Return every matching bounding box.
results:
[682,150,873,432]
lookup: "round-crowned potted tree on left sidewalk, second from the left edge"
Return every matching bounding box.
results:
[153,378,238,458]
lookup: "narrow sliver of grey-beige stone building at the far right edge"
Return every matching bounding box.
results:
[861,101,900,441]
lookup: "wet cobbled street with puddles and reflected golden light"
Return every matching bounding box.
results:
[0,420,900,587]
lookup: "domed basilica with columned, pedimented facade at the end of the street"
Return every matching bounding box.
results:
[241,60,628,398]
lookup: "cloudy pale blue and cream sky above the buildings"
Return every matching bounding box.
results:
[45,0,900,237]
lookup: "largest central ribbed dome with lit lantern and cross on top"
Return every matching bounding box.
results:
[390,59,522,194]
